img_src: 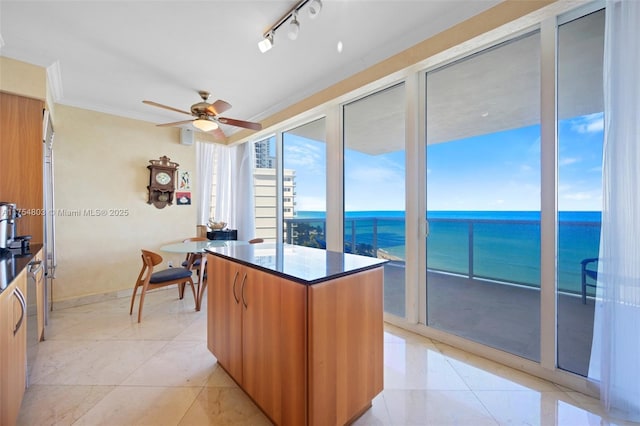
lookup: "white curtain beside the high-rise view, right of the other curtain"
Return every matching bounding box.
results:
[215,142,255,240]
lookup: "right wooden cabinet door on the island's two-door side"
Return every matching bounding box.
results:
[241,268,306,425]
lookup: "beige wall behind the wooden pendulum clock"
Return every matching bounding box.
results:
[53,105,196,303]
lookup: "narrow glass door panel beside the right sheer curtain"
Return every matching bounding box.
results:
[557,10,605,376]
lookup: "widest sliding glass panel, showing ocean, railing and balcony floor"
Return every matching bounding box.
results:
[426,32,540,361]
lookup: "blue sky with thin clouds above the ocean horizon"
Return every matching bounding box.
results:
[284,113,604,215]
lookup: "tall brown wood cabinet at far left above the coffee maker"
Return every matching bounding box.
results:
[0,92,44,243]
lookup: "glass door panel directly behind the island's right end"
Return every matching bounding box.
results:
[343,84,405,317]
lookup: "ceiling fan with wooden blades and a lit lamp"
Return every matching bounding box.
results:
[142,90,262,140]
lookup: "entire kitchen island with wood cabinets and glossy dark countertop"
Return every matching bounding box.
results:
[206,243,386,425]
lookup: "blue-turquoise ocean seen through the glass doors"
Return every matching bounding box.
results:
[296,211,601,294]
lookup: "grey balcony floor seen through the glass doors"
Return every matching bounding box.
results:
[385,262,594,376]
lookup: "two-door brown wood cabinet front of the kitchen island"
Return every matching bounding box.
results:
[207,256,307,425]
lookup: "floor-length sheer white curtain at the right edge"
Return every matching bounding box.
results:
[589,0,640,421]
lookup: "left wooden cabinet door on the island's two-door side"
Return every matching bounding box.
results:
[207,255,243,383]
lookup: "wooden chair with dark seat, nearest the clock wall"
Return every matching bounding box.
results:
[129,250,198,322]
